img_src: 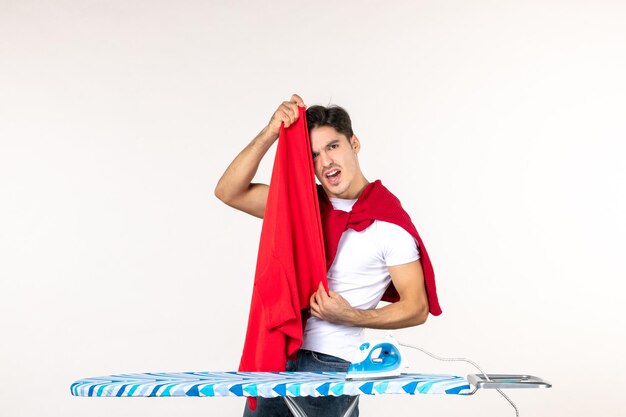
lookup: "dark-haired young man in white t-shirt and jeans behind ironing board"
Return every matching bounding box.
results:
[215,94,438,417]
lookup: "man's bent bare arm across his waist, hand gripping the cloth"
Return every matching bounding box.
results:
[310,260,428,329]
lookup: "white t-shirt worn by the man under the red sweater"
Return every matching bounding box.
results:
[302,198,420,362]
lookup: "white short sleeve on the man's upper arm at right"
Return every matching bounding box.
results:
[377,220,420,266]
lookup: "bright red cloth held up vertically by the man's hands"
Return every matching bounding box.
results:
[239,107,328,409]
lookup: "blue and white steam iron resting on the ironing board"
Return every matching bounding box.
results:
[346,335,408,380]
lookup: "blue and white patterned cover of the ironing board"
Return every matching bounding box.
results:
[71,372,470,397]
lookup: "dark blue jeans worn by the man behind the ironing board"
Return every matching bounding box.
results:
[243,349,359,417]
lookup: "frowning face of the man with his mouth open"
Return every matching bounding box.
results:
[309,126,360,198]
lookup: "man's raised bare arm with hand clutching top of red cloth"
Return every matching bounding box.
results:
[215,94,304,218]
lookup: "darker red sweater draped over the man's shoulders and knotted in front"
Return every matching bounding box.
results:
[318,180,441,316]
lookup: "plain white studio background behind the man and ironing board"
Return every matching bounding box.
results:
[0,0,626,417]
